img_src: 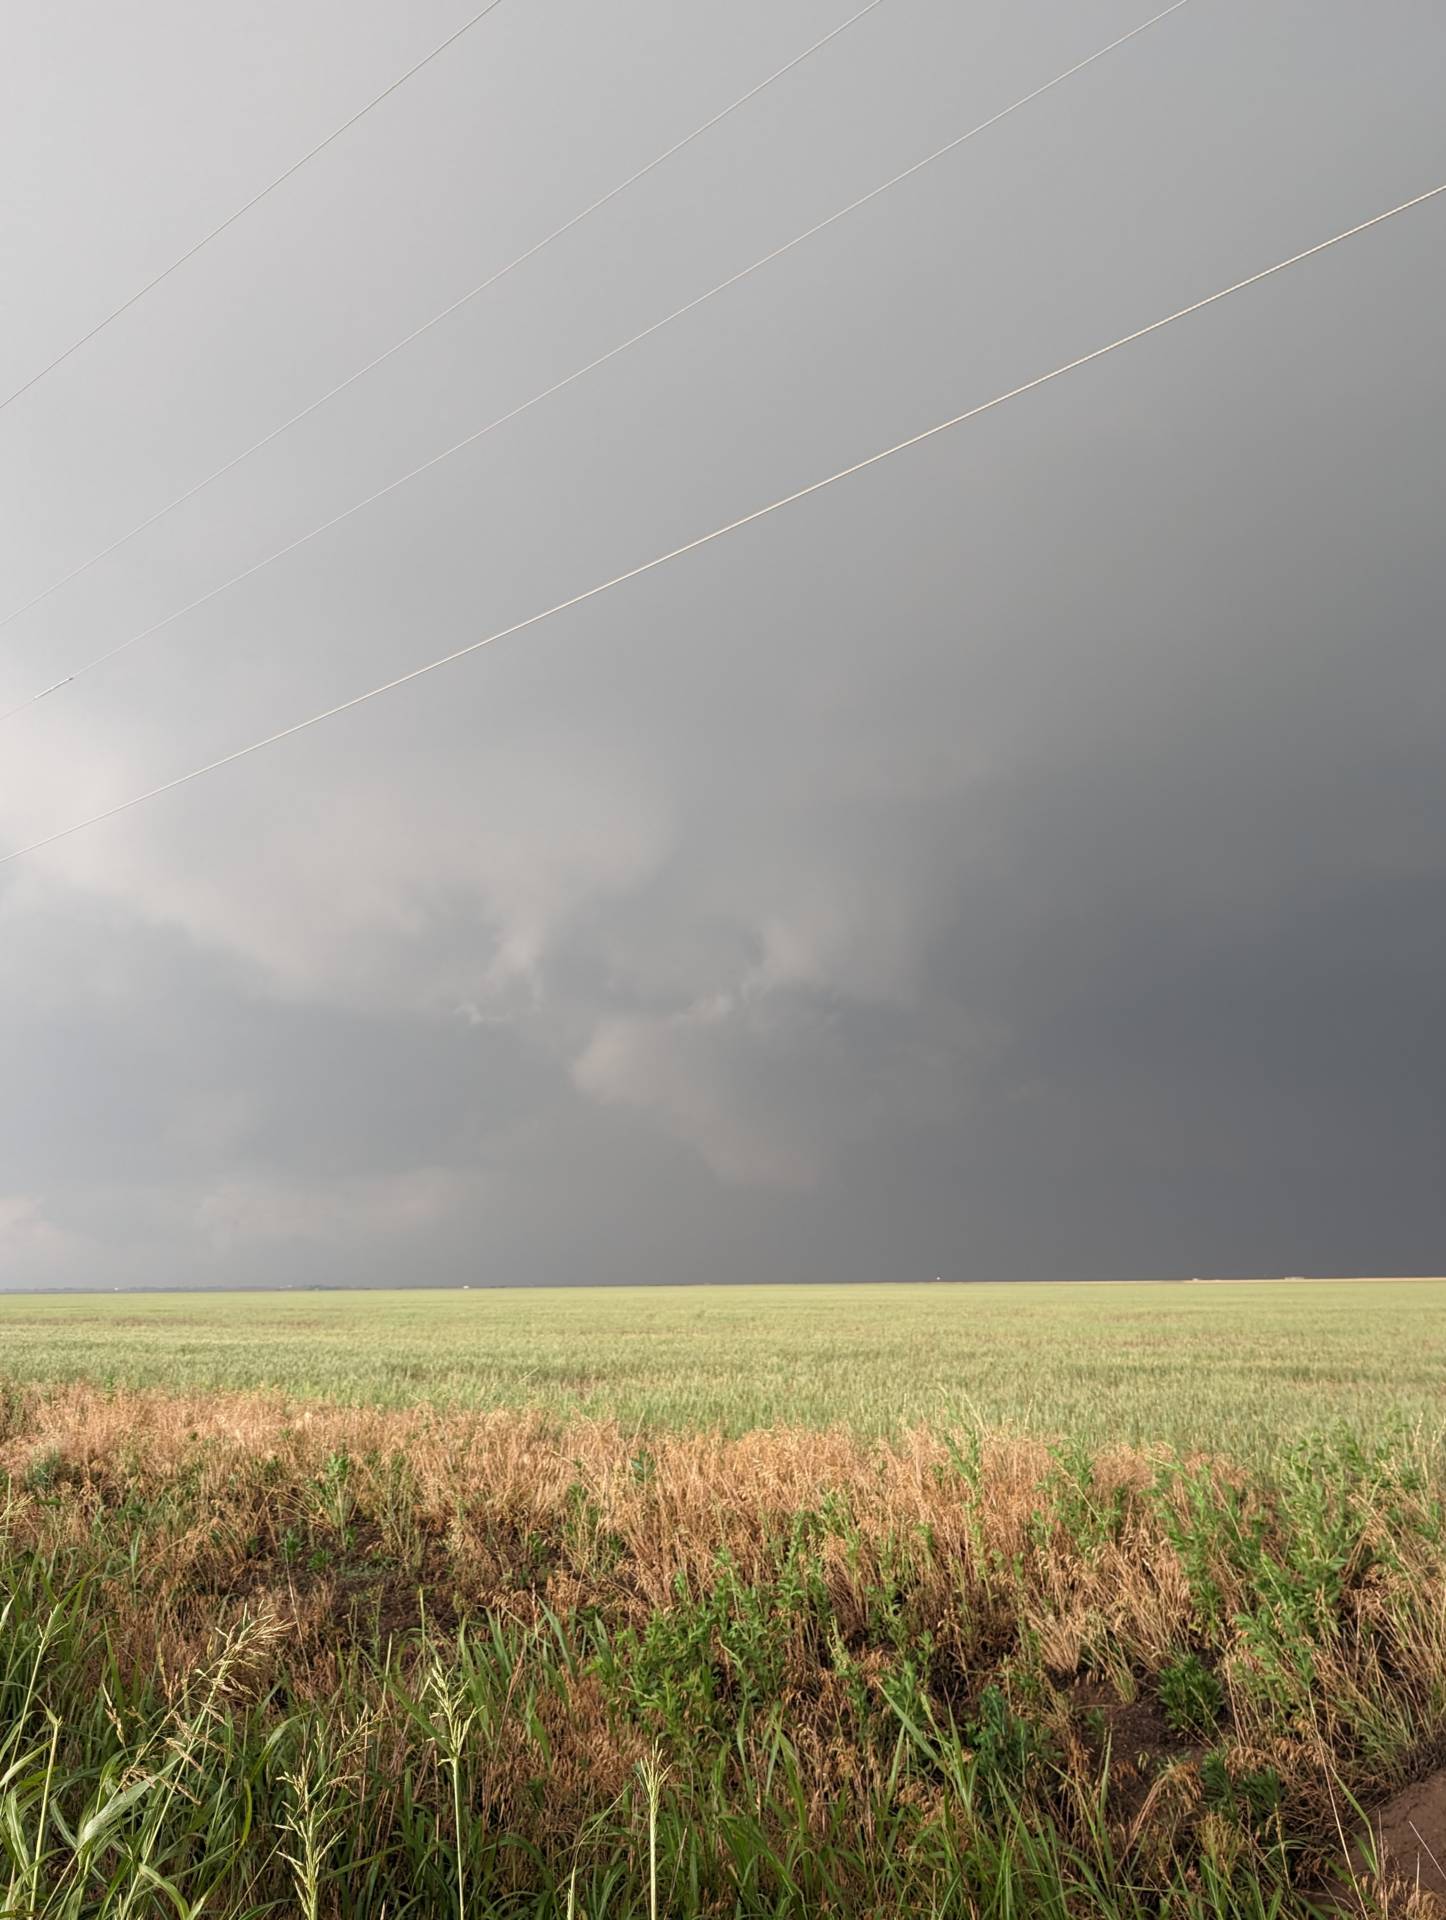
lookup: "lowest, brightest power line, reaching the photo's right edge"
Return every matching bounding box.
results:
[0,182,1446,866]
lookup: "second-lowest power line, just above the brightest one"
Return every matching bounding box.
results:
[0,0,1187,726]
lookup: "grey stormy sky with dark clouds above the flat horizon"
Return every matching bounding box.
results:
[0,0,1446,1288]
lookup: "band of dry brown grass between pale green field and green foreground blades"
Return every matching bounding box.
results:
[0,1386,1446,1912]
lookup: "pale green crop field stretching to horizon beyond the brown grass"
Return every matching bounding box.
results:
[0,1281,1446,1455]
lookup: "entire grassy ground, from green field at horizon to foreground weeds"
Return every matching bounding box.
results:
[0,1283,1446,1920]
